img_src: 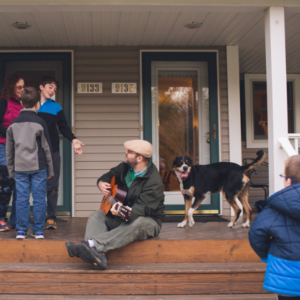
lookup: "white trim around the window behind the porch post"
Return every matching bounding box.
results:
[245,74,300,148]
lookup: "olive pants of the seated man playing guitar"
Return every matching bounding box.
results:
[85,210,160,252]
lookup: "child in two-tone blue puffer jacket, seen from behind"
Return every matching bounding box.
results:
[249,155,300,300]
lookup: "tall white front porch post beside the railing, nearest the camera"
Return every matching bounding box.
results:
[265,7,288,194]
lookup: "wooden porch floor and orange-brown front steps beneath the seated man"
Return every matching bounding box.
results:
[0,217,274,299]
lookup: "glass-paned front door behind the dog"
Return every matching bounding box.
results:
[142,52,219,214]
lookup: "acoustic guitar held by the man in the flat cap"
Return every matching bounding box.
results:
[100,176,131,221]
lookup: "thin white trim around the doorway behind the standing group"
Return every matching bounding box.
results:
[0,49,75,217]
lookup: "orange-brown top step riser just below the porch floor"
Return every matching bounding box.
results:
[0,238,260,263]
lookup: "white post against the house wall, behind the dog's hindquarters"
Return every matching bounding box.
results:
[227,46,243,215]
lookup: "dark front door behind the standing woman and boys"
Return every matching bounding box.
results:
[0,53,71,215]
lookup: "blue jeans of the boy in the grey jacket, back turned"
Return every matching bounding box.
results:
[15,169,47,233]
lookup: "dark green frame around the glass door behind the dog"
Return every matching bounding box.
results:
[142,51,220,212]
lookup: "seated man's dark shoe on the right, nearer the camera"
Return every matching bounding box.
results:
[77,242,107,270]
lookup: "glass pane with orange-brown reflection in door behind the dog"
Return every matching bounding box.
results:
[158,71,199,191]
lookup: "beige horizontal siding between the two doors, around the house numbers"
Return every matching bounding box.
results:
[74,47,140,217]
